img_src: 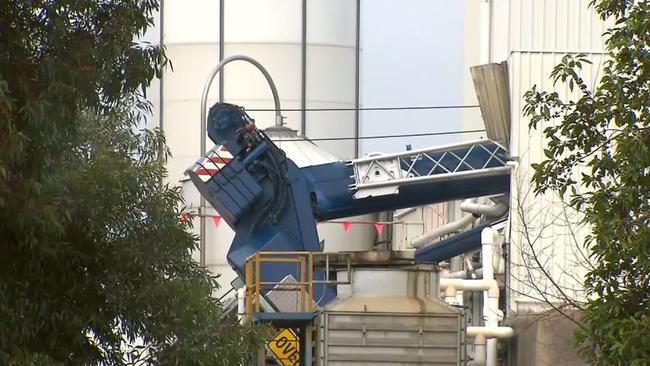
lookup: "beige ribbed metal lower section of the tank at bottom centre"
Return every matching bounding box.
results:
[319,311,465,366]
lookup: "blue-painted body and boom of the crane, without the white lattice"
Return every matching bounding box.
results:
[188,103,510,304]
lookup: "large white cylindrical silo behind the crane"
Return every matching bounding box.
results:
[159,0,374,298]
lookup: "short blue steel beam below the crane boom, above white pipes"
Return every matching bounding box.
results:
[415,219,505,263]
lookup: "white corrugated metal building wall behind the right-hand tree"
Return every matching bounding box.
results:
[491,0,606,311]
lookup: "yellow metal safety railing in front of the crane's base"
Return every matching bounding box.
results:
[245,252,314,320]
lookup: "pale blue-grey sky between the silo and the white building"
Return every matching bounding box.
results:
[360,0,464,154]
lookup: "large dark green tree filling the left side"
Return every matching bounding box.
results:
[0,0,260,365]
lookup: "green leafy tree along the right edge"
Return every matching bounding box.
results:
[524,0,650,365]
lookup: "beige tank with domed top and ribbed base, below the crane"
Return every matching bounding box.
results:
[317,265,466,366]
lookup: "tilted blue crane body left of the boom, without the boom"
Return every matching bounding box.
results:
[188,104,336,303]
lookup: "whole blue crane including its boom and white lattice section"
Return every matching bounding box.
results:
[188,103,510,302]
